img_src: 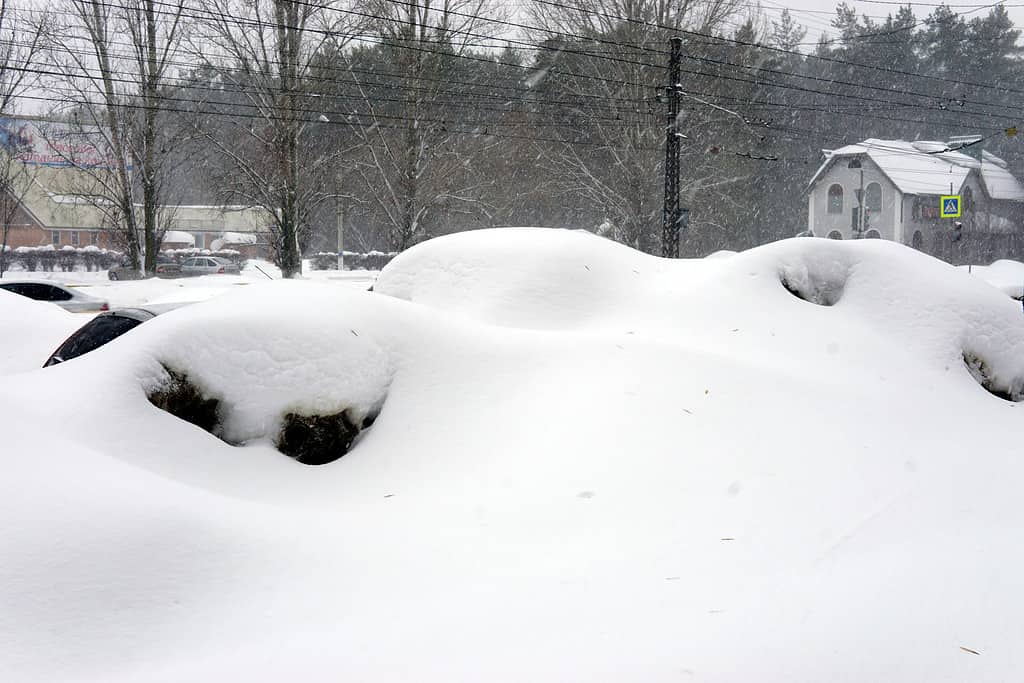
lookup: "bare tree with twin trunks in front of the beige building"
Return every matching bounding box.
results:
[45,0,184,274]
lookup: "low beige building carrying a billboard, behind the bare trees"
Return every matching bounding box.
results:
[0,118,272,256]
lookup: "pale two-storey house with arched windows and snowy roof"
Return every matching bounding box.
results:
[808,137,1024,263]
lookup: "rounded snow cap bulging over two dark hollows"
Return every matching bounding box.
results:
[119,282,394,444]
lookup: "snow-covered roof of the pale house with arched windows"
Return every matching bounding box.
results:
[810,138,991,199]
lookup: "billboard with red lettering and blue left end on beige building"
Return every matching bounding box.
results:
[0,117,116,169]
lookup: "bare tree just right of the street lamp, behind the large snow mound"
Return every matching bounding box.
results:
[352,0,504,250]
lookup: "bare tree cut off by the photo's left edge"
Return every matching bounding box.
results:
[0,0,45,276]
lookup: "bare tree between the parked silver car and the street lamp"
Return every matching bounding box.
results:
[191,0,358,278]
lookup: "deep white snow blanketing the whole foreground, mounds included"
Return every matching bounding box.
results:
[0,229,1024,682]
